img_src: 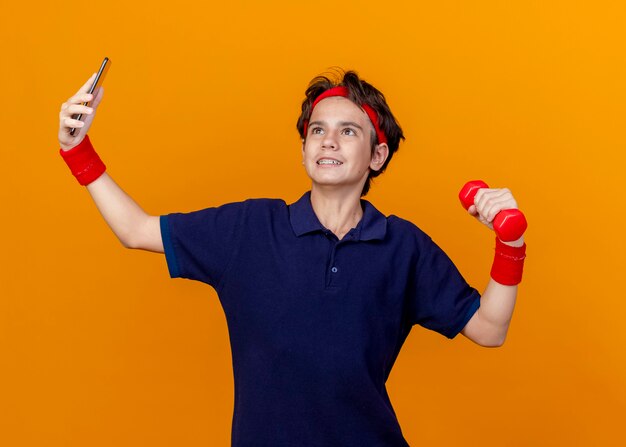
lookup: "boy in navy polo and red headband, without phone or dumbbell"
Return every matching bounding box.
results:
[59,72,525,447]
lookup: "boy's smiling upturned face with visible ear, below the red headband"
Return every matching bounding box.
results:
[302,96,388,195]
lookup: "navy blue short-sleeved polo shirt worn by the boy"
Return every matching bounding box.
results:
[161,193,480,447]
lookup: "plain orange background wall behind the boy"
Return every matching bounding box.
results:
[0,0,626,447]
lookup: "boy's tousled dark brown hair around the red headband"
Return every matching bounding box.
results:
[296,70,404,196]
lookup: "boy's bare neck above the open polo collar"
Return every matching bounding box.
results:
[311,187,363,239]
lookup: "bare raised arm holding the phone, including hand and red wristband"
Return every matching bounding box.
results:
[59,74,163,253]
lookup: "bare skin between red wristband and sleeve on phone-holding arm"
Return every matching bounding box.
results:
[87,172,163,252]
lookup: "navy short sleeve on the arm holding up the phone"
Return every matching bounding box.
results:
[160,202,246,287]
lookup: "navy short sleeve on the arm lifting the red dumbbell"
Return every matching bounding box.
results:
[410,236,480,338]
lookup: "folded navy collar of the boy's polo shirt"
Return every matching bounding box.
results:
[289,191,387,241]
